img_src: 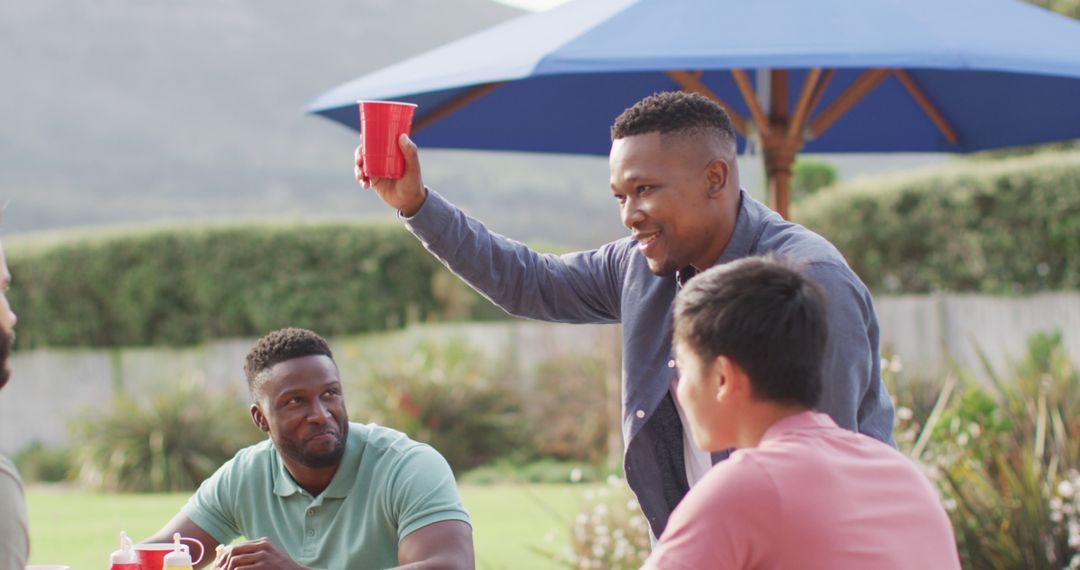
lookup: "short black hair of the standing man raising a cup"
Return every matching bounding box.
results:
[611,91,735,143]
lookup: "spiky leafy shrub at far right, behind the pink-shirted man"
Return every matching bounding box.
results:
[888,334,1080,570]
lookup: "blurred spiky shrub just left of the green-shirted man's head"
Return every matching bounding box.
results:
[73,382,265,492]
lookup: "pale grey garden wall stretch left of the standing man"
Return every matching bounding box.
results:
[0,322,618,457]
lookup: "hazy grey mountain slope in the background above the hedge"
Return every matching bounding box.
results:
[0,0,941,247]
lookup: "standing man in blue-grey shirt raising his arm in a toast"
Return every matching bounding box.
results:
[355,93,893,537]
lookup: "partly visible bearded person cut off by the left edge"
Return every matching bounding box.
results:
[0,233,30,570]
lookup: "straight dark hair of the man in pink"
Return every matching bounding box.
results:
[675,257,827,408]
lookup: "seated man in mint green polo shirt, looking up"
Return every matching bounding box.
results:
[148,328,475,570]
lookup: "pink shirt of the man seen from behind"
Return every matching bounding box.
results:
[647,411,960,570]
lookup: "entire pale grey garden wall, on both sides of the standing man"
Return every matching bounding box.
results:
[0,293,1080,456]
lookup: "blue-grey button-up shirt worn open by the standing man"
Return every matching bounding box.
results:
[406,191,893,537]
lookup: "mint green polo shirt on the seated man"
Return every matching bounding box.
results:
[183,423,469,570]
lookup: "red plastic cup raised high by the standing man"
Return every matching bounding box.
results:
[357,100,416,178]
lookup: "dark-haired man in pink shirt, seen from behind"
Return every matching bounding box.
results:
[646,258,960,570]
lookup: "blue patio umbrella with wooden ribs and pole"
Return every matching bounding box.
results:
[308,0,1080,217]
